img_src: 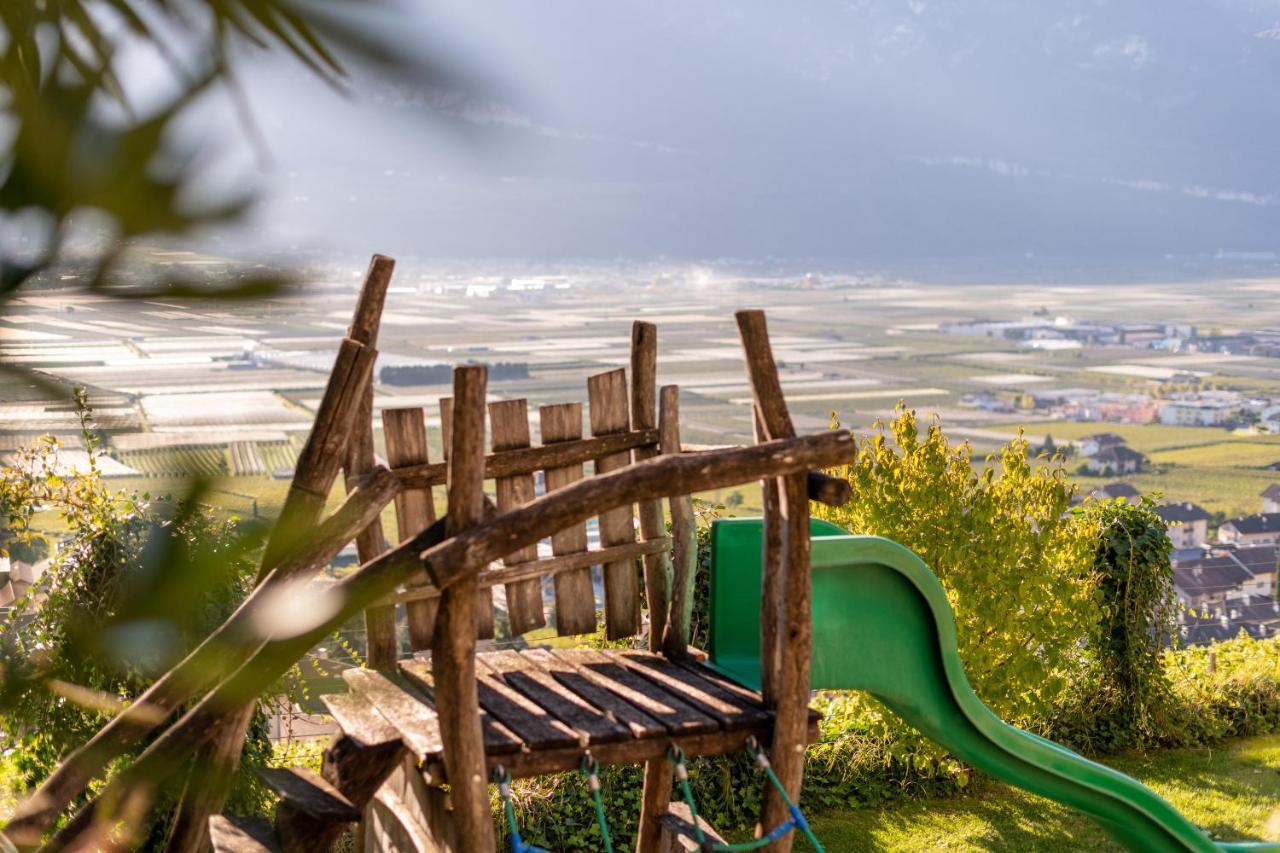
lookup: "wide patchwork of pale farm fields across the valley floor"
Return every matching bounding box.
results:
[0,259,1280,527]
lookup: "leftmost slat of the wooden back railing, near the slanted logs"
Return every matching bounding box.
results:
[383,409,436,652]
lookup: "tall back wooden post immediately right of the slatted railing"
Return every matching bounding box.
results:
[631,320,672,648]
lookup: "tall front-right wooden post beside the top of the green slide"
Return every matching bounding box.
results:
[735,311,813,853]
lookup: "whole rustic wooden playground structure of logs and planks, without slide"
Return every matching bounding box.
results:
[4,256,854,853]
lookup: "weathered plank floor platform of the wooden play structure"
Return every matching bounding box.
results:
[325,649,819,783]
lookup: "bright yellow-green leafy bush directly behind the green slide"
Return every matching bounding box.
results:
[817,409,1100,727]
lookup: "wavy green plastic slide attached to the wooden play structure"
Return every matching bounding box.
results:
[708,519,1280,850]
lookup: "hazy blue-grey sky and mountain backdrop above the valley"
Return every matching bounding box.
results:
[194,0,1280,261]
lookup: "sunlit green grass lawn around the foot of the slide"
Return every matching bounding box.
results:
[796,735,1280,850]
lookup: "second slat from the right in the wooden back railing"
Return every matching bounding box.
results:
[538,403,595,637]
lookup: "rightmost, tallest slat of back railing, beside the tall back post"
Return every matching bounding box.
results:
[586,368,640,639]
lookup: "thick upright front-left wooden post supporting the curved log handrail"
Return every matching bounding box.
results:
[431,366,494,853]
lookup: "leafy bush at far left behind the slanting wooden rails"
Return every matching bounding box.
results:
[0,432,270,841]
